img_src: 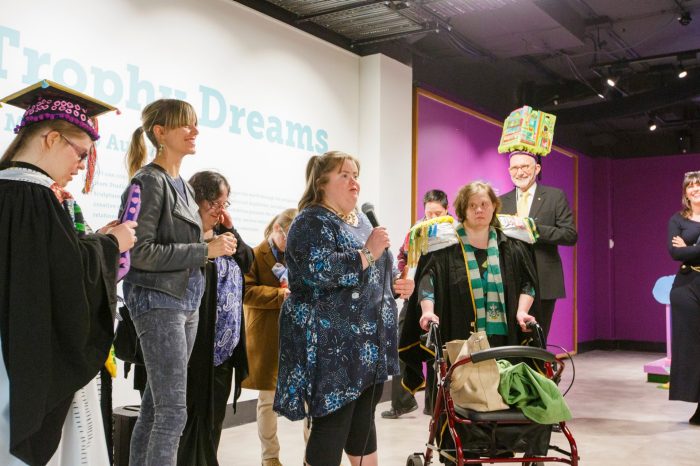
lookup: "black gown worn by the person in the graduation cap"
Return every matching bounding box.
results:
[0,180,119,465]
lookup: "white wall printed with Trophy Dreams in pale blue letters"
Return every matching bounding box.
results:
[0,0,411,405]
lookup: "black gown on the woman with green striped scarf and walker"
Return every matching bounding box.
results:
[399,230,539,392]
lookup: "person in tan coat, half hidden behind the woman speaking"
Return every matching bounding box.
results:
[243,209,297,466]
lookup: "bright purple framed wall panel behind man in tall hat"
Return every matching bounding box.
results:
[415,93,576,349]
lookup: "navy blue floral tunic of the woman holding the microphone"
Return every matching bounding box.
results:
[274,206,399,420]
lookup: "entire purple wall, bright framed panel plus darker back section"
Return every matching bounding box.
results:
[415,91,700,348]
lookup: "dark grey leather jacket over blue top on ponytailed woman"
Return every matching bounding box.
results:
[120,163,207,298]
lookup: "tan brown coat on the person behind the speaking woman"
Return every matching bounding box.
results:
[243,239,284,390]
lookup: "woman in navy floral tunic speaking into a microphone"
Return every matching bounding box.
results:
[274,152,413,466]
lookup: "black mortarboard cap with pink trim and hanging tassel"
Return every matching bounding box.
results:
[0,79,119,192]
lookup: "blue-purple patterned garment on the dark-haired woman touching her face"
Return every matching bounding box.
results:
[214,256,243,366]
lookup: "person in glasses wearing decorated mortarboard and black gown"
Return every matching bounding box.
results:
[0,81,136,466]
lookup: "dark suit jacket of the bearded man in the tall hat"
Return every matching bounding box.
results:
[501,183,578,299]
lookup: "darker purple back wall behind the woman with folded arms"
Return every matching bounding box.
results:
[610,155,700,341]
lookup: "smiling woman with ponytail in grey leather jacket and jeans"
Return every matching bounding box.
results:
[122,99,236,466]
